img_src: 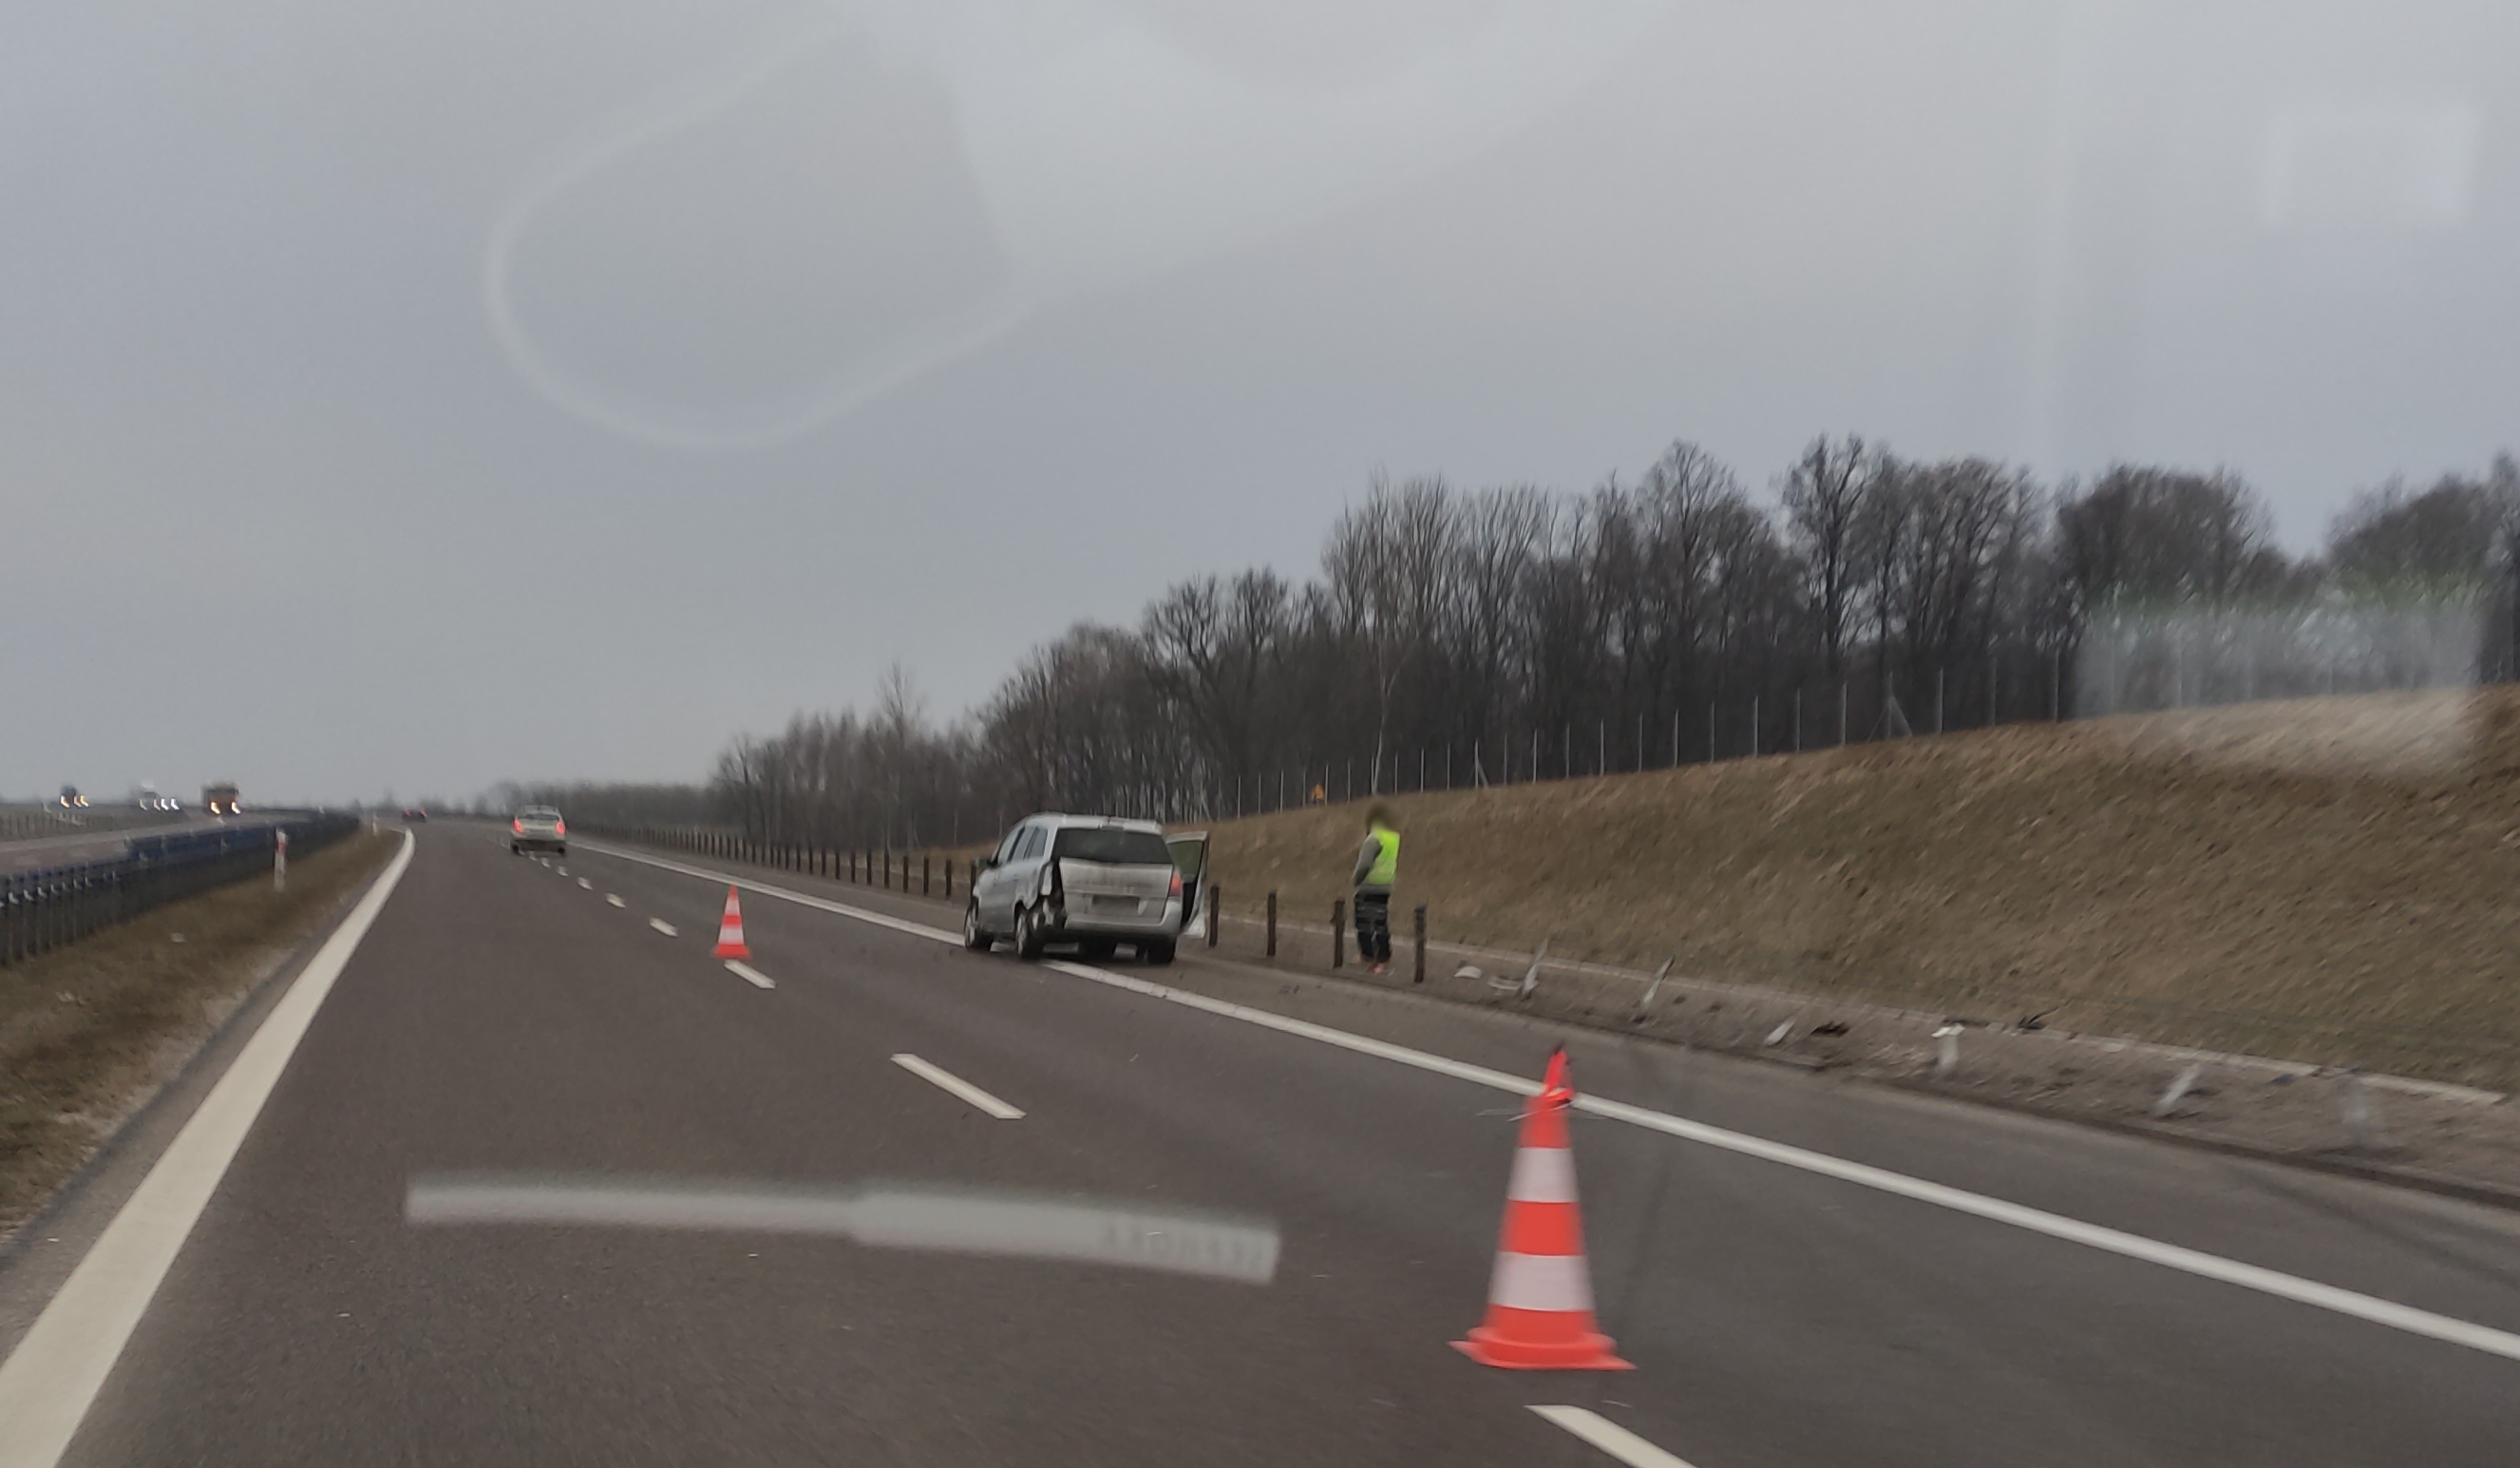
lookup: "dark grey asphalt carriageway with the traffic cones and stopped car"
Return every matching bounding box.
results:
[0,822,2520,1468]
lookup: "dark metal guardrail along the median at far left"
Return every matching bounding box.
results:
[0,812,358,966]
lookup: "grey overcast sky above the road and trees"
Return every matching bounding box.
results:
[0,0,2520,800]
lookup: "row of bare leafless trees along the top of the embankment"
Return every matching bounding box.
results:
[506,436,2520,845]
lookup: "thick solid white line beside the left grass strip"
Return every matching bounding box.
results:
[0,829,413,1468]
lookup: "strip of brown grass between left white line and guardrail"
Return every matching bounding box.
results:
[0,829,403,1236]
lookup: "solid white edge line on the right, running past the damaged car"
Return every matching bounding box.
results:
[590,843,2520,1363]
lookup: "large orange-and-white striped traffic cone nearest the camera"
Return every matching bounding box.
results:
[1451,1049,1633,1372]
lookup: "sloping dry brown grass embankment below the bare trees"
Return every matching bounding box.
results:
[1194,689,2520,1087]
